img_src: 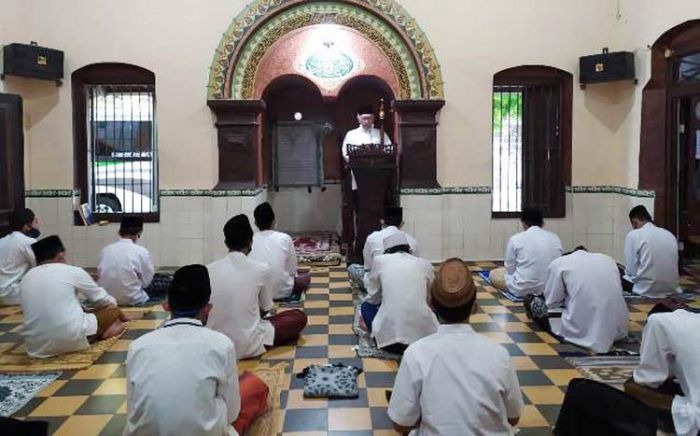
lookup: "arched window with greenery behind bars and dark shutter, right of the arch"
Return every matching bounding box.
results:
[492,66,572,217]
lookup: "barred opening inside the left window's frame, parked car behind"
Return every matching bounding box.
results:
[85,84,158,216]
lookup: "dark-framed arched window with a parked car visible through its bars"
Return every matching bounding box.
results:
[72,64,158,221]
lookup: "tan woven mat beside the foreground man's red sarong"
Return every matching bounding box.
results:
[238,360,287,436]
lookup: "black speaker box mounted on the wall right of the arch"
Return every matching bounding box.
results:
[579,51,635,84]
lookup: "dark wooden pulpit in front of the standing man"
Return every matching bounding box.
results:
[348,144,396,259]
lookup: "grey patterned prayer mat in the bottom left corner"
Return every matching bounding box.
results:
[0,372,61,417]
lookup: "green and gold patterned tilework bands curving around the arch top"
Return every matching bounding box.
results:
[208,0,444,99]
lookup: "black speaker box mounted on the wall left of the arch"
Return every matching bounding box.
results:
[2,43,63,80]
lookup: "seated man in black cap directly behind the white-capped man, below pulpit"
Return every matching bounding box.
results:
[348,206,418,289]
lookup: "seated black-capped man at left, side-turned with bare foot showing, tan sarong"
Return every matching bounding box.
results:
[20,236,127,358]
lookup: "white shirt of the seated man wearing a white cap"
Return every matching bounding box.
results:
[365,253,438,348]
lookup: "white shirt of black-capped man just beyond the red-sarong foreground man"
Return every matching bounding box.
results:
[207,251,275,359]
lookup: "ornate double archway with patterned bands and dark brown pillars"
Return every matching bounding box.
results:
[207,0,444,188]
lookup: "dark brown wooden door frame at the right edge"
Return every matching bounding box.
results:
[639,20,700,235]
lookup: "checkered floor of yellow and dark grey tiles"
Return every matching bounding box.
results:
[0,262,696,436]
